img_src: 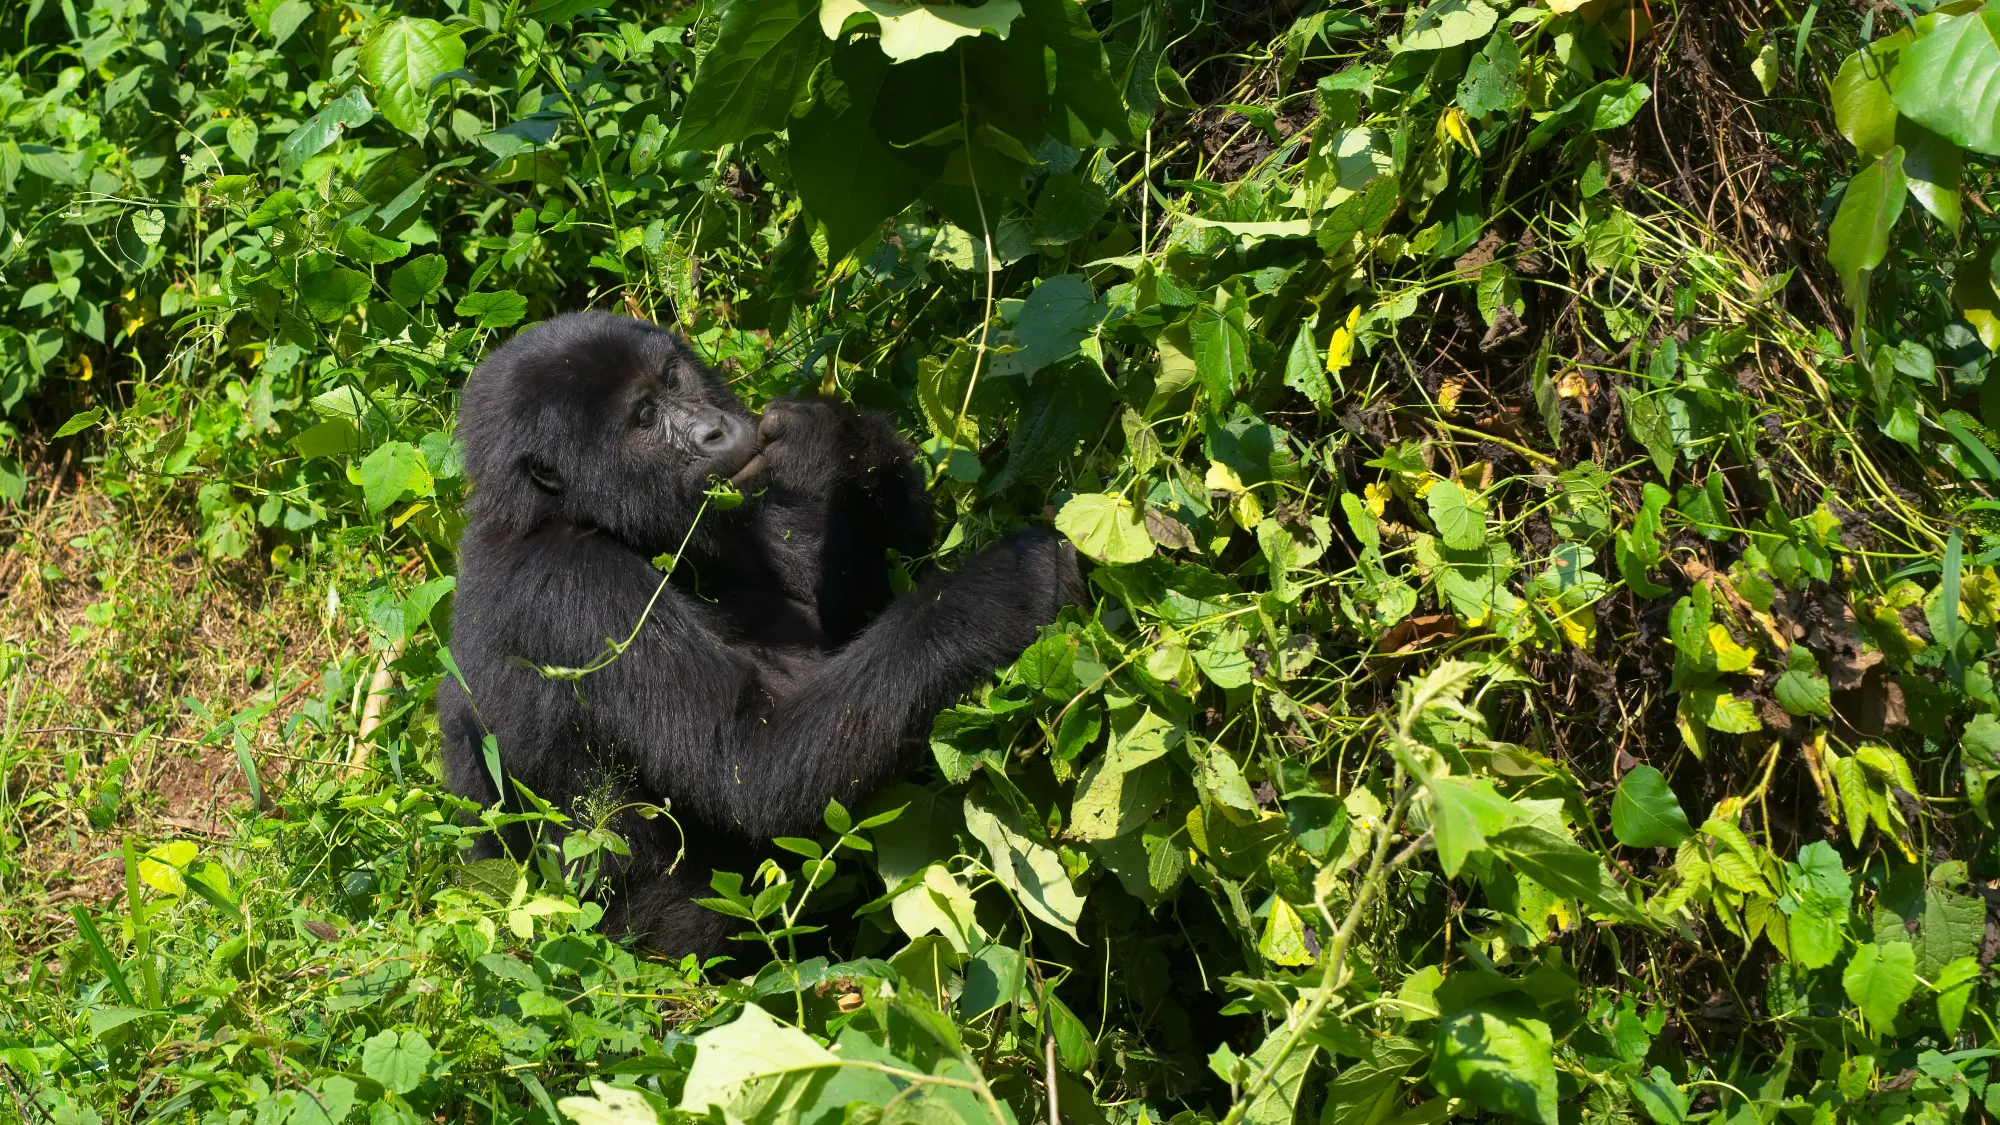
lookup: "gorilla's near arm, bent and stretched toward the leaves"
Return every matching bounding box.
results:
[568,530,1082,839]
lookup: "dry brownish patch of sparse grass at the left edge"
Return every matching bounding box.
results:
[0,464,332,951]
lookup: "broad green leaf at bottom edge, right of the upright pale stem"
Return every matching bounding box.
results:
[1430,993,1556,1125]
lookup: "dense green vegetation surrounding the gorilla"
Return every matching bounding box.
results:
[0,0,2000,1125]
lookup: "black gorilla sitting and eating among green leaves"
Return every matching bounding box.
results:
[438,312,1082,953]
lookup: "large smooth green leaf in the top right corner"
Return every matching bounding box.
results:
[1894,6,2000,156]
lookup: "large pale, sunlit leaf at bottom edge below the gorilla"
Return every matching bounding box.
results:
[678,1005,840,1121]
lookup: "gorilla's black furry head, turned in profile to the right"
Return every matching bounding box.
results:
[458,312,758,552]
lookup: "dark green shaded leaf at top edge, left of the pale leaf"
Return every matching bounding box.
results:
[666,0,828,152]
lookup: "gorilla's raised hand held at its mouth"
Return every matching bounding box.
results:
[738,398,910,496]
